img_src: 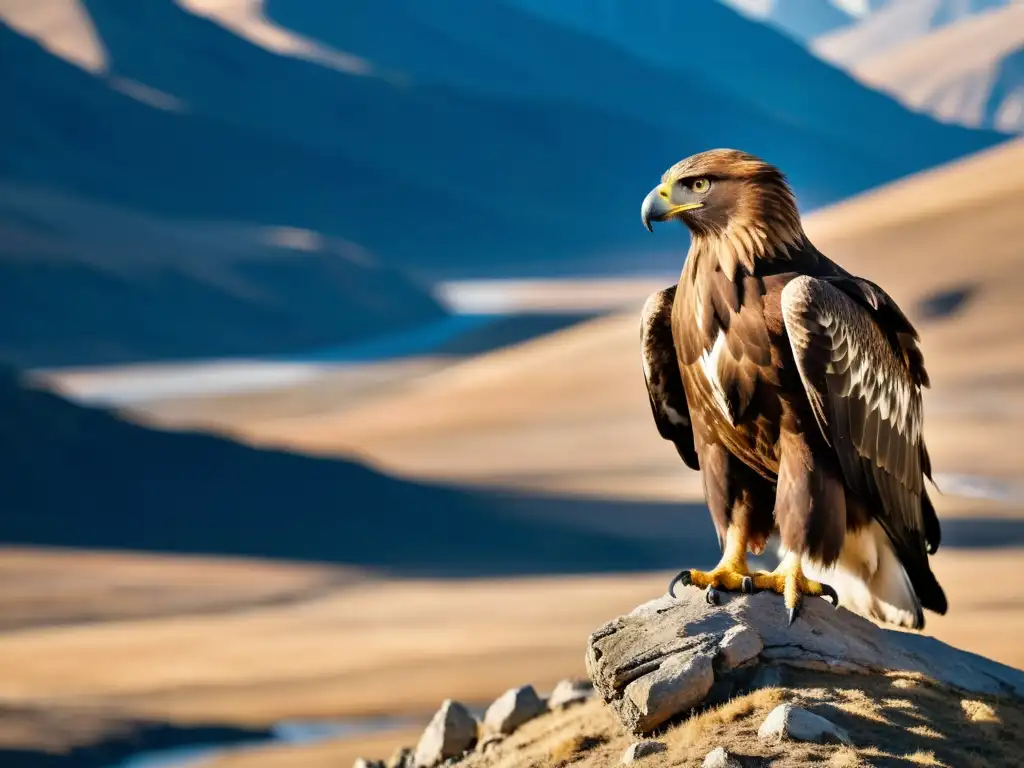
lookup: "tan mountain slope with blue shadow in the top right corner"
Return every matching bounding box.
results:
[839,3,1024,133]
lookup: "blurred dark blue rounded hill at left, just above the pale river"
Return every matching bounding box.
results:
[0,184,445,367]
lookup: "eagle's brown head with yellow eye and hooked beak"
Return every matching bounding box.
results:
[640,150,803,261]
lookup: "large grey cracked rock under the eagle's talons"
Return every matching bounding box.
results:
[586,588,1024,734]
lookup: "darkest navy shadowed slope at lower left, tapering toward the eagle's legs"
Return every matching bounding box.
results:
[0,370,714,575]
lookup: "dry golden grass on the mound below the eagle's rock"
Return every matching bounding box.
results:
[230,672,1024,768]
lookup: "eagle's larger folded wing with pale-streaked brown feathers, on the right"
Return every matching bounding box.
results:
[782,275,946,612]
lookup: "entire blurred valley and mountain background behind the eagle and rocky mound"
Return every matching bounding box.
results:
[0,0,1024,768]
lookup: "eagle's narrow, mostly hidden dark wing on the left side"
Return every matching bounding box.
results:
[640,286,700,470]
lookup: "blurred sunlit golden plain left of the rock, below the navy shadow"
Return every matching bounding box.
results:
[0,552,667,724]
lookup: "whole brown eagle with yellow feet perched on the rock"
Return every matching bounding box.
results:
[641,150,946,629]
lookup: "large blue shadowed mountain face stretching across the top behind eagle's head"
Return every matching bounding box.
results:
[0,0,998,276]
